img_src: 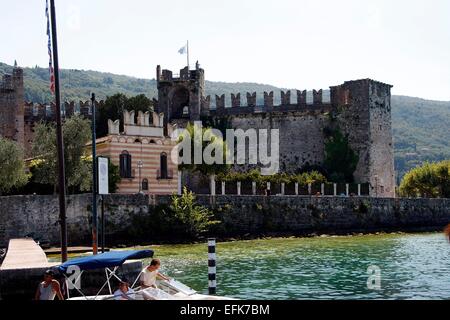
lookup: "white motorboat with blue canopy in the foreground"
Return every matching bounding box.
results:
[56,250,235,300]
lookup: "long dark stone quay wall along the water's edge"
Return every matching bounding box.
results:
[0,194,450,247]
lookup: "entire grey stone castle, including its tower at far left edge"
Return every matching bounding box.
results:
[0,63,395,197]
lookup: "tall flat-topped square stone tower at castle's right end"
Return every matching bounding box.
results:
[330,79,395,197]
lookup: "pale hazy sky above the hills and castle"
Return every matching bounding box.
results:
[0,0,450,101]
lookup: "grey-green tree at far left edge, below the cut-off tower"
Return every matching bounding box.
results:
[0,137,28,194]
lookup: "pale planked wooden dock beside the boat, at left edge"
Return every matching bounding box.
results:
[0,238,56,271]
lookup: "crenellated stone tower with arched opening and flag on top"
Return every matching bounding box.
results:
[156,63,205,127]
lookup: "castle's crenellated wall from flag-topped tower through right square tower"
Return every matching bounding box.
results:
[157,66,395,197]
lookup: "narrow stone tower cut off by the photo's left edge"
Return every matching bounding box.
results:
[0,62,25,146]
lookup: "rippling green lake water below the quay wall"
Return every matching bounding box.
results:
[132,234,450,299]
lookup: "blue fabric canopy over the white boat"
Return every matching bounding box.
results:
[57,250,153,273]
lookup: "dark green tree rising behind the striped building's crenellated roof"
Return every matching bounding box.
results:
[96,93,153,138]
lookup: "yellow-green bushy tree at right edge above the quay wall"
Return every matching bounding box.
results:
[399,160,450,198]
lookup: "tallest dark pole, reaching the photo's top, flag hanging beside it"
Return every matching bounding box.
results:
[50,0,67,262]
